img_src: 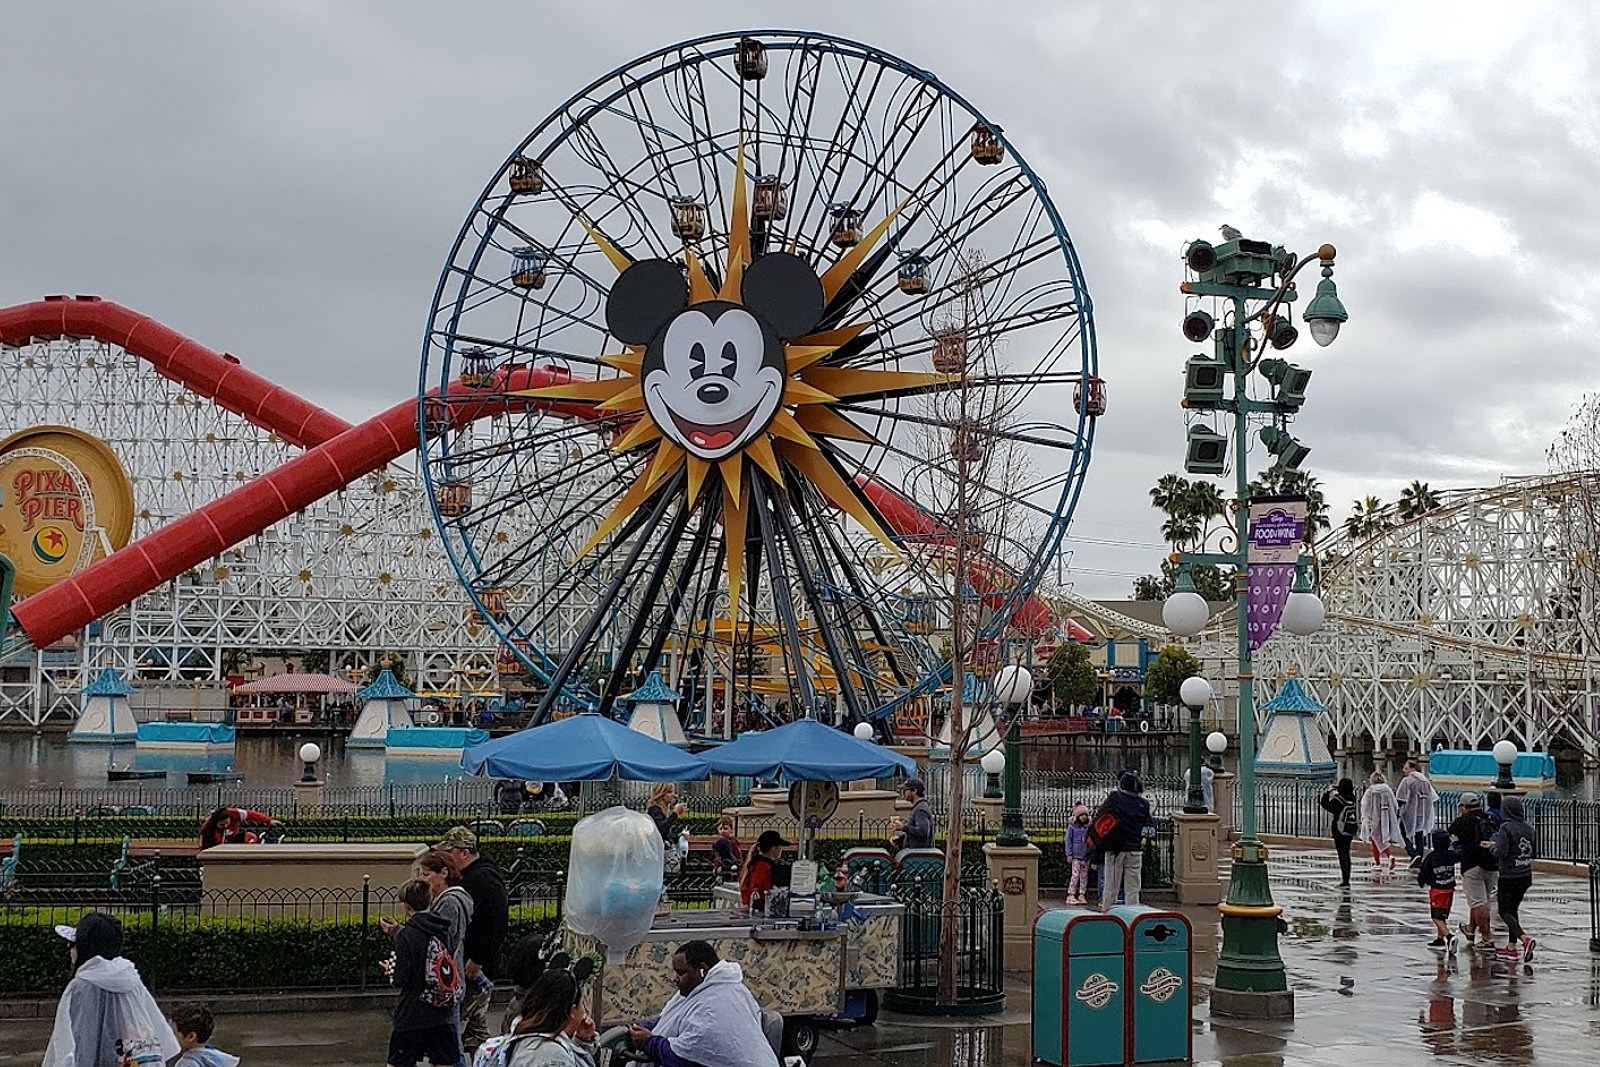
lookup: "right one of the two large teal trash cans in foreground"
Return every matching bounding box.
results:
[1110,905,1194,1064]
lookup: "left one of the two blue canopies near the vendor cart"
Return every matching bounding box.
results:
[461,713,710,782]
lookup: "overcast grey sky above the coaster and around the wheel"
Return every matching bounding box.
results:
[0,0,1600,597]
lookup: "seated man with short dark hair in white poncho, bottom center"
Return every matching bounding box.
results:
[629,941,778,1067]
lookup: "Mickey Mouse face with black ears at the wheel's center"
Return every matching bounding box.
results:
[606,253,822,462]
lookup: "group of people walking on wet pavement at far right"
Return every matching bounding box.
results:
[1322,760,1538,963]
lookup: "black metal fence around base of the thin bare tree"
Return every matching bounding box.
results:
[886,881,1005,1013]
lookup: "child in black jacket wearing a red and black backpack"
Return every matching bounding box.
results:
[387,878,462,1067]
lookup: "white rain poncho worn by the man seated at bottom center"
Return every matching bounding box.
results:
[645,960,778,1067]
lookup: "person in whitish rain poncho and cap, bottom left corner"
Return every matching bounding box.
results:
[42,912,181,1067]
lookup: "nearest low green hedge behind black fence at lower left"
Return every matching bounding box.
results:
[0,904,555,997]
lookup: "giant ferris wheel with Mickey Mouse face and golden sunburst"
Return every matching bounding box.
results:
[418,30,1106,729]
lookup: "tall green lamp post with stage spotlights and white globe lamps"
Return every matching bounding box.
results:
[1162,227,1349,1017]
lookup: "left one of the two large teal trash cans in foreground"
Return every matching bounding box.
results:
[1034,907,1130,1067]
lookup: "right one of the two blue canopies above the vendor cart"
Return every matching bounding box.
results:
[706,718,917,782]
